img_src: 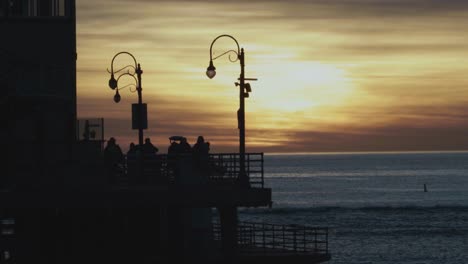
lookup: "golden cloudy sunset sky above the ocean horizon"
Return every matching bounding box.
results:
[76,0,468,153]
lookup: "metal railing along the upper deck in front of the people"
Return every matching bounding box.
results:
[117,153,264,188]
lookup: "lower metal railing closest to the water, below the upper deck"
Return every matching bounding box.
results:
[213,222,328,255]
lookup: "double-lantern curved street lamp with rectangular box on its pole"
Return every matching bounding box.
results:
[107,51,148,146]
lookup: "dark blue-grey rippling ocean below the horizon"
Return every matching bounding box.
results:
[239,152,468,264]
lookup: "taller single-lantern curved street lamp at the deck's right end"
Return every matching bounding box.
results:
[206,35,257,186]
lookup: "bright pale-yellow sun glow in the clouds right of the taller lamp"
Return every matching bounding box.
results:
[254,61,353,112]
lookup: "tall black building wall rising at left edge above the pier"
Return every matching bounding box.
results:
[0,0,76,189]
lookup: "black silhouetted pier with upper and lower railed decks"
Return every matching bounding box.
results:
[0,150,330,263]
